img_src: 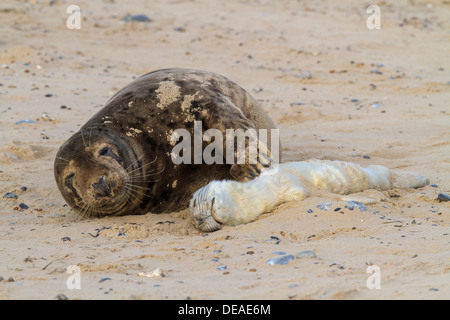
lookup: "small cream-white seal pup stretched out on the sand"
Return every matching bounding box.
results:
[189,160,430,232]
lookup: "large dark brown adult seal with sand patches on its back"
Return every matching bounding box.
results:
[54,69,276,216]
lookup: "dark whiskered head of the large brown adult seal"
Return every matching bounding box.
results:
[54,130,149,216]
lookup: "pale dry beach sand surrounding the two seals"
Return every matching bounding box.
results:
[0,0,450,299]
